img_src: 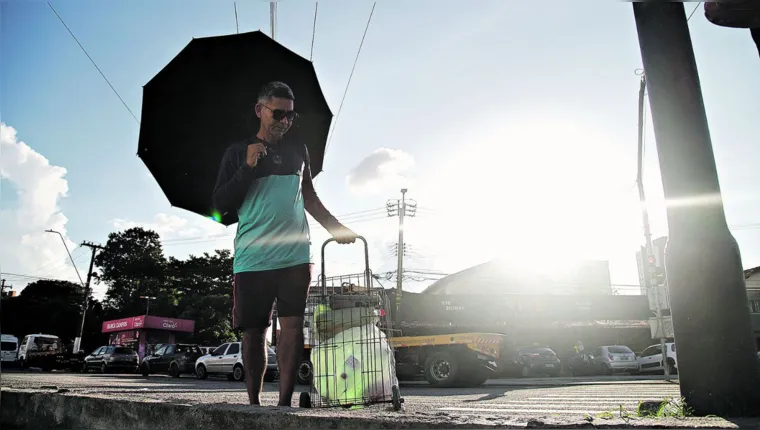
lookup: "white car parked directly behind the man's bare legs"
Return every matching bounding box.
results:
[195,342,279,382]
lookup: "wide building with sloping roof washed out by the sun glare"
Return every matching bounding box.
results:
[423,260,612,295]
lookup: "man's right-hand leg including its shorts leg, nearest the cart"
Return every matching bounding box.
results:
[277,264,311,406]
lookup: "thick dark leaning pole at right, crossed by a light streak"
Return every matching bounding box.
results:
[632,1,760,417]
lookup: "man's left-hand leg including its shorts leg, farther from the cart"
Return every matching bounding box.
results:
[232,271,276,405]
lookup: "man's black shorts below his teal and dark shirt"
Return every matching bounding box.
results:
[232,263,313,329]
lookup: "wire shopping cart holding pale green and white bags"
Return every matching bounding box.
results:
[299,236,403,411]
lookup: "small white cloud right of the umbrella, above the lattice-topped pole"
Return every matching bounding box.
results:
[346,148,414,194]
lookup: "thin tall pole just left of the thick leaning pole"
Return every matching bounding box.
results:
[636,74,670,380]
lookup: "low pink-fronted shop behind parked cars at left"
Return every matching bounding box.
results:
[102,315,195,360]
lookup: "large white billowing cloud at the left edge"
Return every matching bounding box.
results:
[0,122,87,290]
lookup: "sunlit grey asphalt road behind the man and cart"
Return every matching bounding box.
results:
[0,370,680,419]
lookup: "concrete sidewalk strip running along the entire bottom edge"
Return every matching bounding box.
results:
[0,387,760,429]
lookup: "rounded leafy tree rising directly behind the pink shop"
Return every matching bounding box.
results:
[95,227,168,316]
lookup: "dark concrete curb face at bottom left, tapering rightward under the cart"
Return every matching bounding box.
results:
[0,388,526,429]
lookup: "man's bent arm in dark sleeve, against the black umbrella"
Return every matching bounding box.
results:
[213,146,254,215]
